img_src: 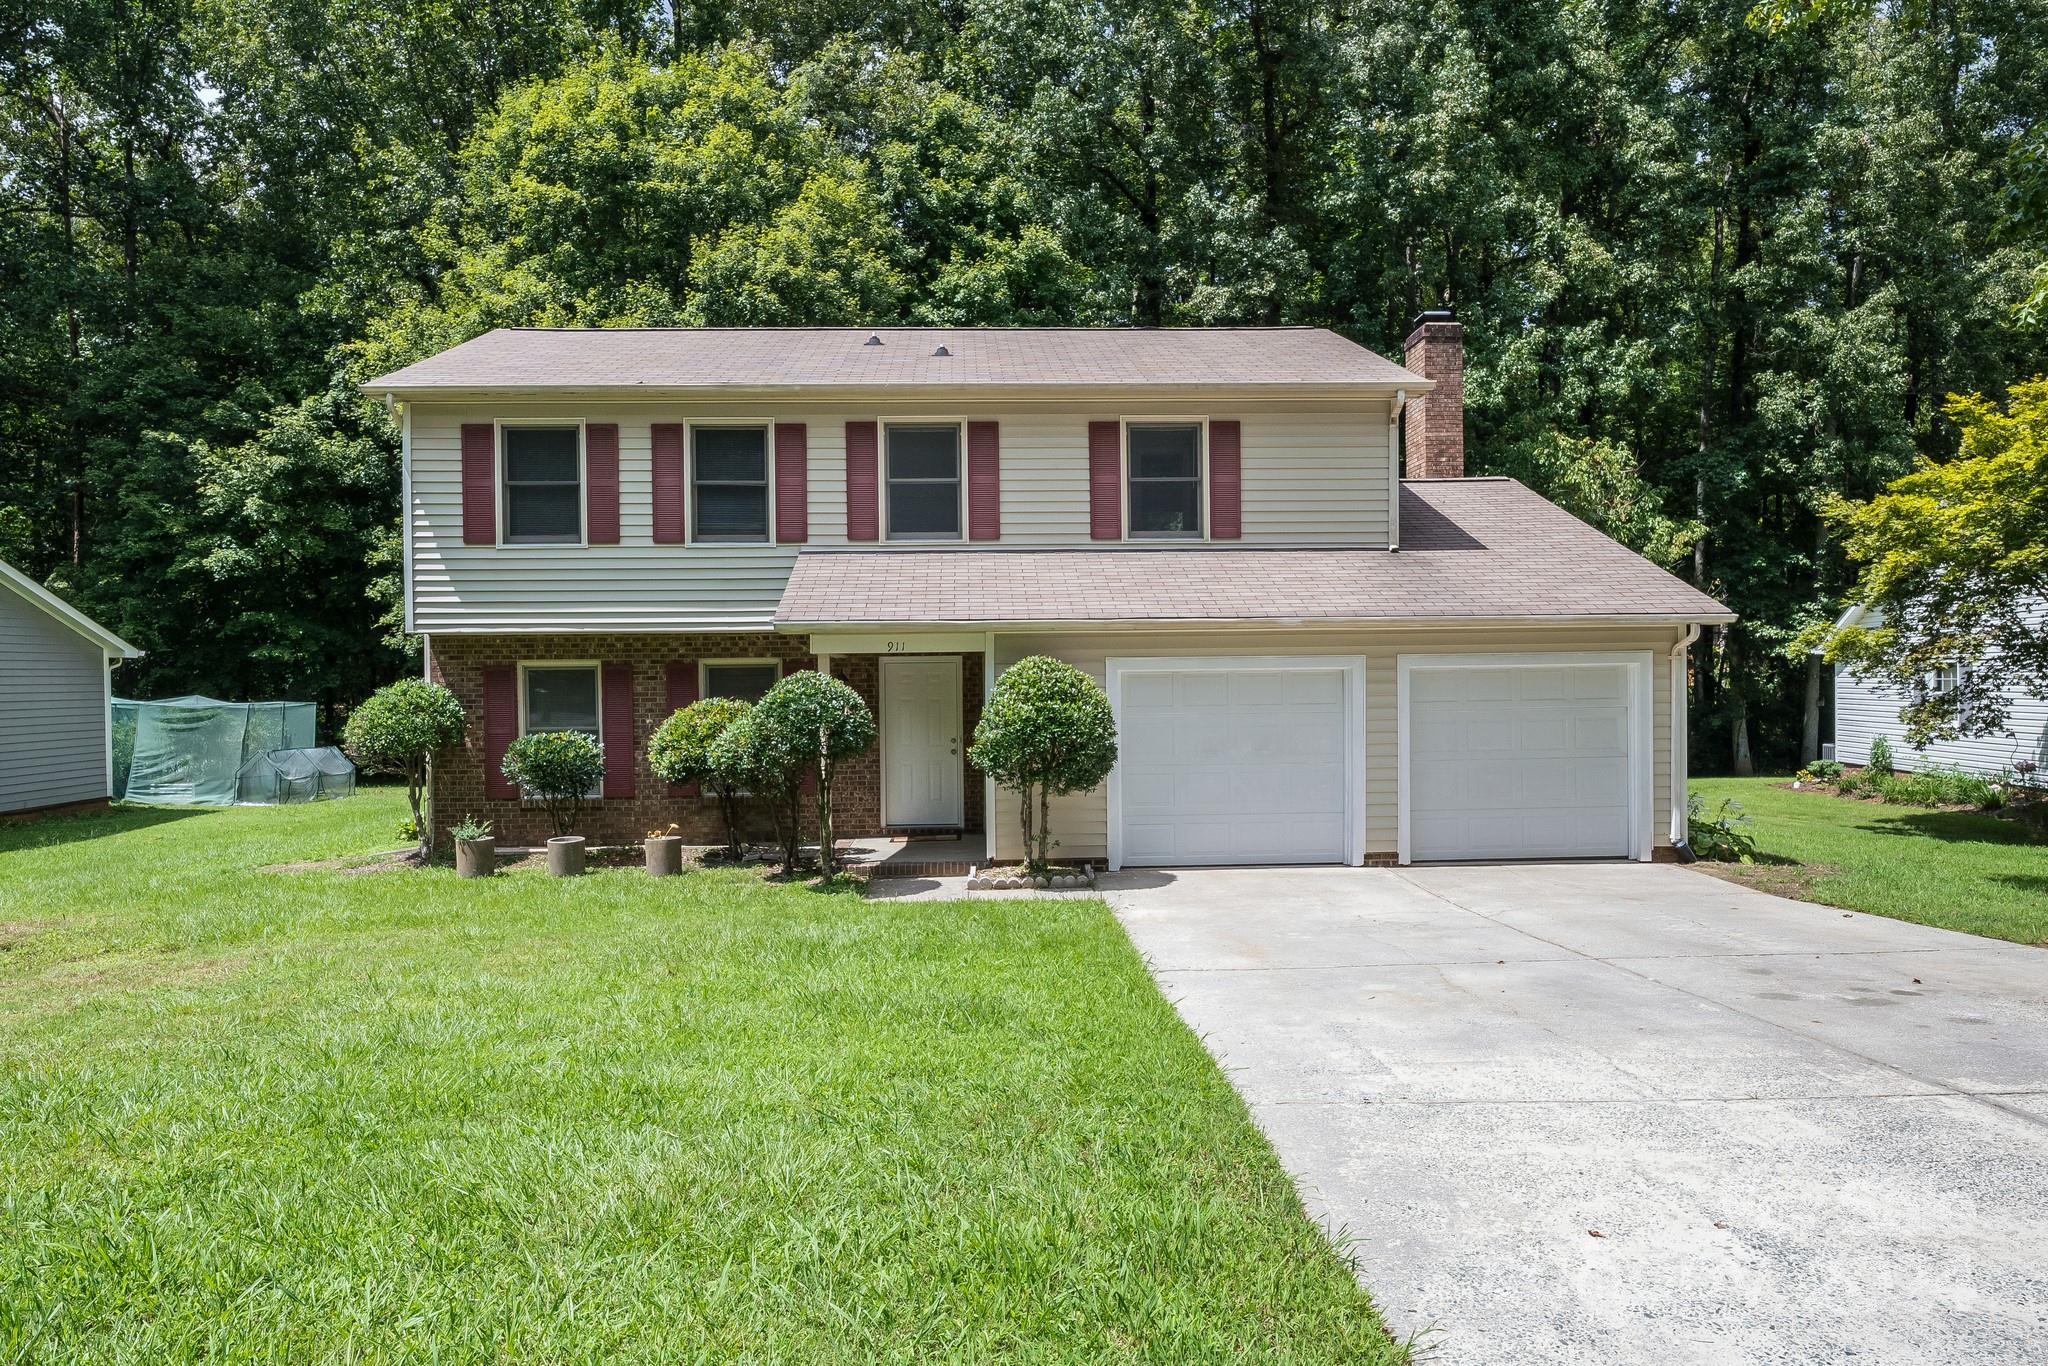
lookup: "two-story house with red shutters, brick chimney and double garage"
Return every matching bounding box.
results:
[367,313,1731,866]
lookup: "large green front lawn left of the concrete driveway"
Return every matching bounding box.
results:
[0,788,1405,1362]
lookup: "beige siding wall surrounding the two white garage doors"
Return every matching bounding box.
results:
[991,627,1679,858]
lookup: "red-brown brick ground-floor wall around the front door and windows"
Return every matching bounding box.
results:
[428,633,983,844]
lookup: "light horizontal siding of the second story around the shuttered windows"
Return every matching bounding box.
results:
[408,397,1391,633]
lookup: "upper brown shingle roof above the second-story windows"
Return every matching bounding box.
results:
[362,328,1427,393]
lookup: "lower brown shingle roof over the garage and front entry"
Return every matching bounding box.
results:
[776,479,1733,627]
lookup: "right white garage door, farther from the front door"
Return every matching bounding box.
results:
[1407,664,1634,860]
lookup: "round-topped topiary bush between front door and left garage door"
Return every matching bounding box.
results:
[967,655,1116,874]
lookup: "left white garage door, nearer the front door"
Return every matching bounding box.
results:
[1110,659,1364,864]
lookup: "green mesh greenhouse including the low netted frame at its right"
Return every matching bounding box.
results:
[115,696,356,807]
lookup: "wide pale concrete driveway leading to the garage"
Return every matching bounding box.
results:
[1104,864,2048,1366]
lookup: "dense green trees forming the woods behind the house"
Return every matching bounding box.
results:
[0,0,2048,766]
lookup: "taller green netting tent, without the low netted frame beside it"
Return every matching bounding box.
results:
[115,696,323,807]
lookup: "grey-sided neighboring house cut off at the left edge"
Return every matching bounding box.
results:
[0,563,141,813]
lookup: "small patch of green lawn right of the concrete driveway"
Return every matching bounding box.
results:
[1692,778,2048,944]
